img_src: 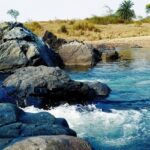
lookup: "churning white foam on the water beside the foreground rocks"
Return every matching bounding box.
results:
[24,104,148,146]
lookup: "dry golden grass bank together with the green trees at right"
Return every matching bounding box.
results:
[25,0,150,41]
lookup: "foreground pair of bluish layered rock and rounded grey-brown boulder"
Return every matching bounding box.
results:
[0,103,90,150]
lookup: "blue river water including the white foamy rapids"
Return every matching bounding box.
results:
[1,49,150,150]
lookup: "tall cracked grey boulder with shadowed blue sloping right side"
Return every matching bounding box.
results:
[0,22,62,71]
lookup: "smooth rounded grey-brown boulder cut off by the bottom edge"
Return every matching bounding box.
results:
[5,135,91,150]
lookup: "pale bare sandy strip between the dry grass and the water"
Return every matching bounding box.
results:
[86,36,150,48]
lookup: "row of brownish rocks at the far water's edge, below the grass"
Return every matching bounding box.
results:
[43,31,119,67]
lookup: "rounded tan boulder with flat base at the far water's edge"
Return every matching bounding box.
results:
[58,41,100,67]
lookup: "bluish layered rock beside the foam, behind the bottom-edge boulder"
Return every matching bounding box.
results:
[0,103,76,149]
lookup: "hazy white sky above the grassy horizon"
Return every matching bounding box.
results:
[0,0,150,21]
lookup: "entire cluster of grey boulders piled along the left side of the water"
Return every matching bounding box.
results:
[0,22,113,150]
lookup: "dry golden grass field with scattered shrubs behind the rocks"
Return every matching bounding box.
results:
[25,16,150,41]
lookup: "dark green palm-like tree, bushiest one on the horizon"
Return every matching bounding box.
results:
[117,0,135,22]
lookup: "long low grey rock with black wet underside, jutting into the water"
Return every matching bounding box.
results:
[2,66,110,108]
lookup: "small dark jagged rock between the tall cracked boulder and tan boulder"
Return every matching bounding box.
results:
[43,31,67,51]
